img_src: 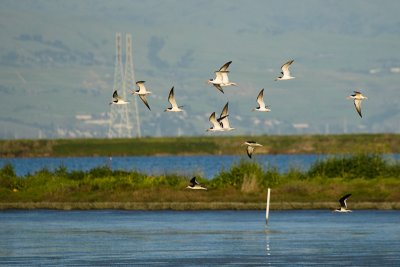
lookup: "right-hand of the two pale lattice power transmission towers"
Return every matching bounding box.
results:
[124,33,142,138]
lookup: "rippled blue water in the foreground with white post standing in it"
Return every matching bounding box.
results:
[0,210,400,266]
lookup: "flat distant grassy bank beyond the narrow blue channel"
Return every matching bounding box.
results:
[0,134,400,157]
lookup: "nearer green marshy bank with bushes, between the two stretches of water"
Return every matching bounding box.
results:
[0,154,400,210]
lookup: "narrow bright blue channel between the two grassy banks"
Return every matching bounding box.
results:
[0,154,400,179]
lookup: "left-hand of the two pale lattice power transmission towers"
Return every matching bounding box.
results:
[108,32,132,138]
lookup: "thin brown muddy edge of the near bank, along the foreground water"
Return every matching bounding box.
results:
[0,202,400,211]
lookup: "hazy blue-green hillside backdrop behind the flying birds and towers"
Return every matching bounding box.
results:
[0,0,400,138]
